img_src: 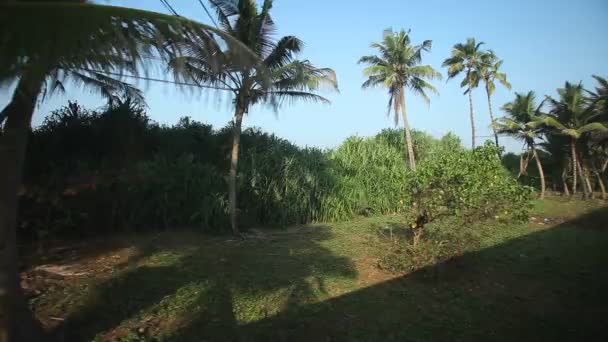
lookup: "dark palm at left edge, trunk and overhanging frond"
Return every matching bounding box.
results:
[0,1,245,341]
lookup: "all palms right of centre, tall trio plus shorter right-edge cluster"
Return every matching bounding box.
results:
[359,30,608,202]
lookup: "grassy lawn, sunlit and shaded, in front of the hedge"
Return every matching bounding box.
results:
[24,198,608,341]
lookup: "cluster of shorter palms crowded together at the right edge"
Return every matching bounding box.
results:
[492,76,608,199]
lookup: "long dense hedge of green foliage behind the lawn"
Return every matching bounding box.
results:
[20,100,528,237]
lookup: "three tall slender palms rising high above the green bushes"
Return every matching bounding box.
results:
[359,30,511,170]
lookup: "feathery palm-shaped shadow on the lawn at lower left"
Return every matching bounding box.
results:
[64,226,356,341]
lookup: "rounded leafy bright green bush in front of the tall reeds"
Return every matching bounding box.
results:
[408,142,532,221]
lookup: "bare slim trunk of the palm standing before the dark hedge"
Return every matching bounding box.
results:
[228,104,245,235]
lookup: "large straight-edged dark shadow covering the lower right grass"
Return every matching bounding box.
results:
[228,208,608,341]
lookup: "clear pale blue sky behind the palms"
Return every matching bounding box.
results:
[0,0,608,151]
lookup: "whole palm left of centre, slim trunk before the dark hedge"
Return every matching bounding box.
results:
[170,0,337,234]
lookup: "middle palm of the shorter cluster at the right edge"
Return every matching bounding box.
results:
[532,82,608,195]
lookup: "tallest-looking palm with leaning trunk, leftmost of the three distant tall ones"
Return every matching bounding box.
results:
[359,30,442,171]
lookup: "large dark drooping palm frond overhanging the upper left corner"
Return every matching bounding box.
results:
[0,2,256,96]
